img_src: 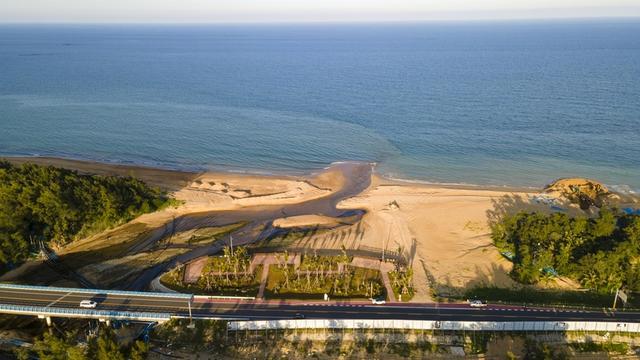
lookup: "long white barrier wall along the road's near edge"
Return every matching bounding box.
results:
[228,319,640,332]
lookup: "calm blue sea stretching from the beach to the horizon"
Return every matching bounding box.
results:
[0,20,640,190]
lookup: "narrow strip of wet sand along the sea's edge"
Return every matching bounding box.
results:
[0,155,547,193]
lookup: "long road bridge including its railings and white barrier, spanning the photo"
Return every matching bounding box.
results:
[0,284,640,331]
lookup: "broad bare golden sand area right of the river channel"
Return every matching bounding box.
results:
[338,178,584,301]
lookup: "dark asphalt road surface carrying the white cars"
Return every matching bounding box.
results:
[0,288,640,322]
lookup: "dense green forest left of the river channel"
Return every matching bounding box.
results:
[0,161,170,272]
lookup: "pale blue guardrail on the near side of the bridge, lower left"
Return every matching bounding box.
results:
[0,304,171,322]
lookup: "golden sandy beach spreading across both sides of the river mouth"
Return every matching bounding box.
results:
[5,158,592,296]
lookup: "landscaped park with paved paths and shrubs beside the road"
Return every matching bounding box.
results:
[160,246,414,301]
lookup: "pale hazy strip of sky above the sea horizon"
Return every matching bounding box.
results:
[0,0,640,23]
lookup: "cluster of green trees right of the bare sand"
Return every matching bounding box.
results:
[492,208,640,293]
